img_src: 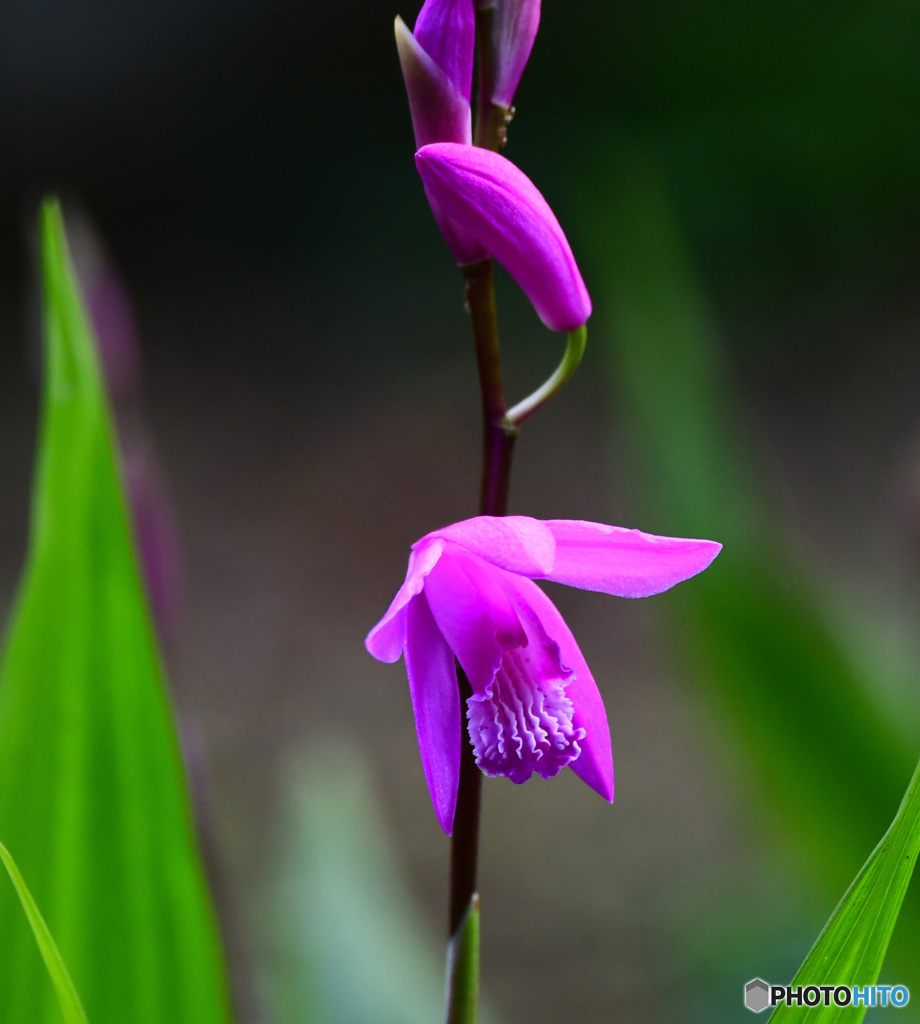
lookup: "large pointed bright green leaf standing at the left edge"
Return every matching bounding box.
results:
[0,202,229,1024]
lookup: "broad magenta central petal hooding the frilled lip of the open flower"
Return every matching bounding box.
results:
[425,544,527,693]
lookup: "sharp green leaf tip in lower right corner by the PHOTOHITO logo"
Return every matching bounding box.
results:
[769,765,920,1024]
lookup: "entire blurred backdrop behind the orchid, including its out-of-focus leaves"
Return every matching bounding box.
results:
[0,0,920,1024]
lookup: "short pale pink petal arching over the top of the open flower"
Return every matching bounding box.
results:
[418,515,555,577]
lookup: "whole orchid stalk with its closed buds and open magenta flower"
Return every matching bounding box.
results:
[383,0,720,1024]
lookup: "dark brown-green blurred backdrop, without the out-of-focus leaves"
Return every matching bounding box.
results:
[0,0,920,1024]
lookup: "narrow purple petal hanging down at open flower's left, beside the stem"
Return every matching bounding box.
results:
[406,594,462,836]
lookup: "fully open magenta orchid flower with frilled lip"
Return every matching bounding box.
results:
[365,516,721,835]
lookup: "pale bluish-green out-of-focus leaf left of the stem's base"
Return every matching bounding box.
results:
[265,736,496,1024]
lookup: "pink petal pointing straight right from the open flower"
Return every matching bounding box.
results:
[542,519,722,597]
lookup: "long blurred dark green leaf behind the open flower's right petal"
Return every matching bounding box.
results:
[582,154,920,984]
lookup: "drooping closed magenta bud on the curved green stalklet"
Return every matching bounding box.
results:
[415,142,591,331]
